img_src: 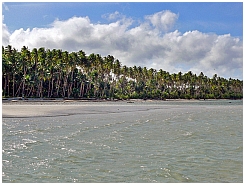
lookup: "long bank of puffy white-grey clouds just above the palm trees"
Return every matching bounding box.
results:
[2,10,243,79]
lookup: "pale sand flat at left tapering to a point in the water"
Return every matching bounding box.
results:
[2,100,168,118]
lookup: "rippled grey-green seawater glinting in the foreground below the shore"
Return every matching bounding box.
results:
[2,100,243,183]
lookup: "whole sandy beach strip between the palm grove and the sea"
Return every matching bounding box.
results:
[2,99,237,118]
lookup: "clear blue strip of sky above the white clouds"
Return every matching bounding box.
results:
[2,2,243,37]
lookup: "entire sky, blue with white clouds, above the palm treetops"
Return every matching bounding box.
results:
[2,2,243,79]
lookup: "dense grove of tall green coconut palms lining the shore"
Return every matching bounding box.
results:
[2,45,243,99]
